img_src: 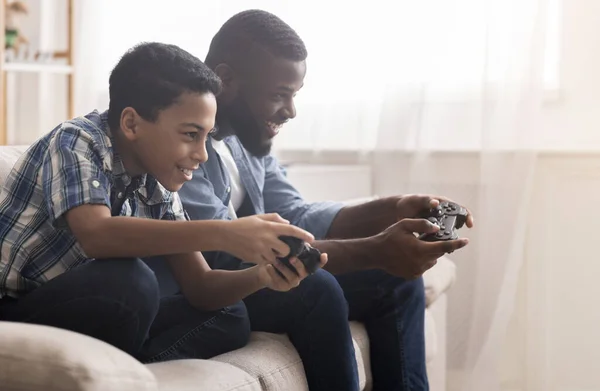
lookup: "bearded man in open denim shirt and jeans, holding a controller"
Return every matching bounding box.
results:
[180,10,473,391]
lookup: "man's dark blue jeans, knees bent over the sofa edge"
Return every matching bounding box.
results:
[244,270,429,391]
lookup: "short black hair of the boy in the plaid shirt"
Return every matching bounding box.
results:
[108,42,221,129]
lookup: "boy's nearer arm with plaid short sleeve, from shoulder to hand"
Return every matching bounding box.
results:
[41,129,312,263]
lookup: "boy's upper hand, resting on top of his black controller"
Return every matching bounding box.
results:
[223,213,315,265]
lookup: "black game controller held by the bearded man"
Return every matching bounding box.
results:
[419,202,467,242]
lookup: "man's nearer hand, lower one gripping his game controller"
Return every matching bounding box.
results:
[373,219,469,279]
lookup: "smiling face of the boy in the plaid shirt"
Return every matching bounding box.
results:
[121,93,217,192]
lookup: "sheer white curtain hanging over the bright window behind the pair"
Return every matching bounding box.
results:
[77,0,560,391]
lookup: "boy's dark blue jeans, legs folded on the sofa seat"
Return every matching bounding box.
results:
[0,259,250,362]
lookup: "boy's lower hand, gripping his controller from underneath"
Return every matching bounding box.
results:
[254,254,327,292]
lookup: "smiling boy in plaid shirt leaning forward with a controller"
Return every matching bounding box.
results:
[0,43,326,362]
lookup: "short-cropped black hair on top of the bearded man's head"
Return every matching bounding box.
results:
[206,10,307,69]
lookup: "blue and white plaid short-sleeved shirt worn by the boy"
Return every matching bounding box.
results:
[0,111,187,298]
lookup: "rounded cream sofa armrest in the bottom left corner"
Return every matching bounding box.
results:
[0,322,158,391]
